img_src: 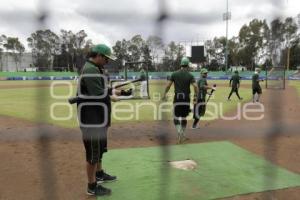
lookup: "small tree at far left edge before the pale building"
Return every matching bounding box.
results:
[3,37,25,71]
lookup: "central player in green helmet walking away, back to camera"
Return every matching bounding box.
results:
[163,57,198,143]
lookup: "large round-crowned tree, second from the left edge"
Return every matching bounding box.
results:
[27,29,60,71]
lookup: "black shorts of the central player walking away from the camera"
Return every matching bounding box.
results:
[173,97,191,117]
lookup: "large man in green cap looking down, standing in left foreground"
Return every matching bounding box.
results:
[75,44,131,196]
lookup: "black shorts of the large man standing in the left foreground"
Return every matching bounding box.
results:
[80,127,107,164]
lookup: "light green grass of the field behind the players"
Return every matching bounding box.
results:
[0,81,251,128]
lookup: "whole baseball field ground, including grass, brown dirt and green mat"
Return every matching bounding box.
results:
[0,80,300,200]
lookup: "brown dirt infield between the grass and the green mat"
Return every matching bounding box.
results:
[0,87,300,200]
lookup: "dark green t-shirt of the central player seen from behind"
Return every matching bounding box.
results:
[170,69,195,95]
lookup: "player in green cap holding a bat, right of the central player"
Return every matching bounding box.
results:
[192,68,215,129]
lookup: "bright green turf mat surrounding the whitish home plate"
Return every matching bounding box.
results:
[99,141,300,200]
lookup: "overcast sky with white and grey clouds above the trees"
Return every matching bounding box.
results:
[0,0,300,50]
